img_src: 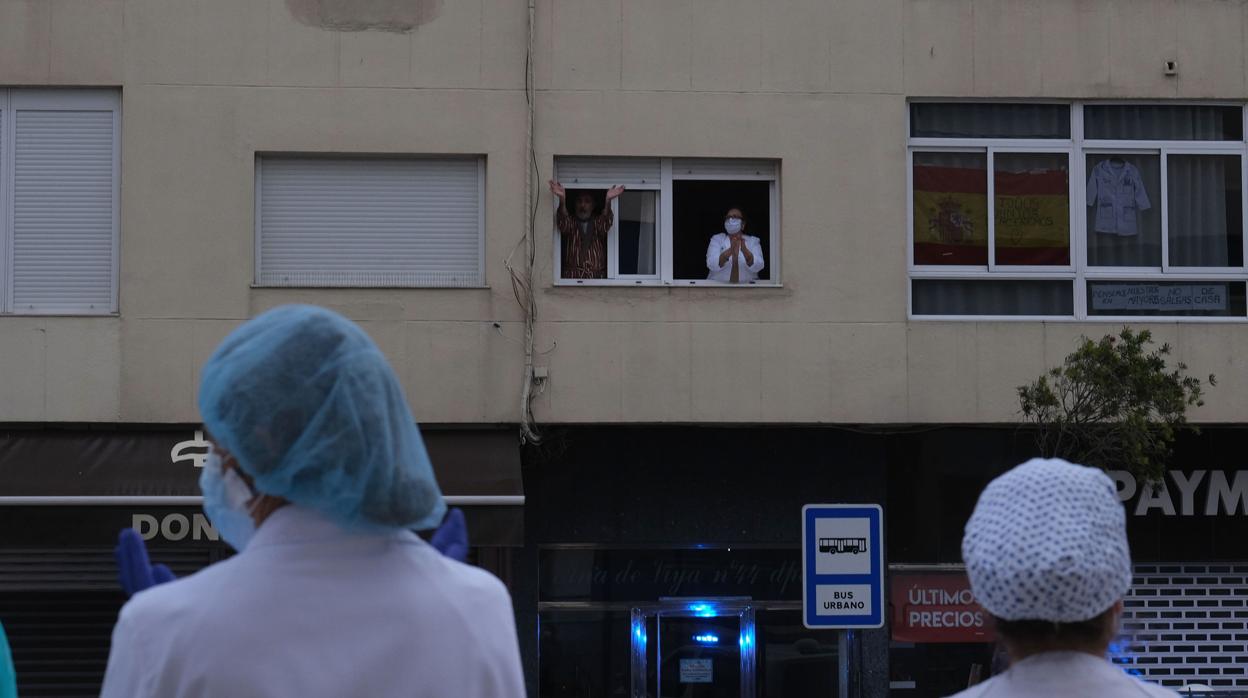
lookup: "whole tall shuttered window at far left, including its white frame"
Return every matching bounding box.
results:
[0,89,121,315]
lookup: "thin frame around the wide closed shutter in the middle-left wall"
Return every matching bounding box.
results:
[251,151,489,290]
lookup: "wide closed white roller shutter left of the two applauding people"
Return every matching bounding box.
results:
[257,157,484,286]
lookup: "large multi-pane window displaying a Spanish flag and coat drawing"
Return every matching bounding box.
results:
[907,101,1248,320]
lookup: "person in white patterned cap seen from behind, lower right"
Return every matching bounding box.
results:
[957,458,1177,698]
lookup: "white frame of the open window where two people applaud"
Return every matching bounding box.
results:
[552,156,782,288]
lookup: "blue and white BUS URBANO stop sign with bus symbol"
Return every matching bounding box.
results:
[801,504,885,629]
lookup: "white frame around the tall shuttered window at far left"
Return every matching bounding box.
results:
[0,87,121,316]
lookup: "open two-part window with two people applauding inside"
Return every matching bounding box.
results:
[554,156,780,286]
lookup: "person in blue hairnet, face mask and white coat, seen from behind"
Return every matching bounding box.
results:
[102,306,524,698]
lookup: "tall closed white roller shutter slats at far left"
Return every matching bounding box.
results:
[11,106,117,313]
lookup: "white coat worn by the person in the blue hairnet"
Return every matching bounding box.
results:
[101,506,524,698]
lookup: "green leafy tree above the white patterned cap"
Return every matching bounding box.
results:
[1018,327,1217,482]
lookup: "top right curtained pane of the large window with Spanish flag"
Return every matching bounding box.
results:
[1083,104,1244,141]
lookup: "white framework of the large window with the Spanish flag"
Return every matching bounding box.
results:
[906,99,1248,323]
